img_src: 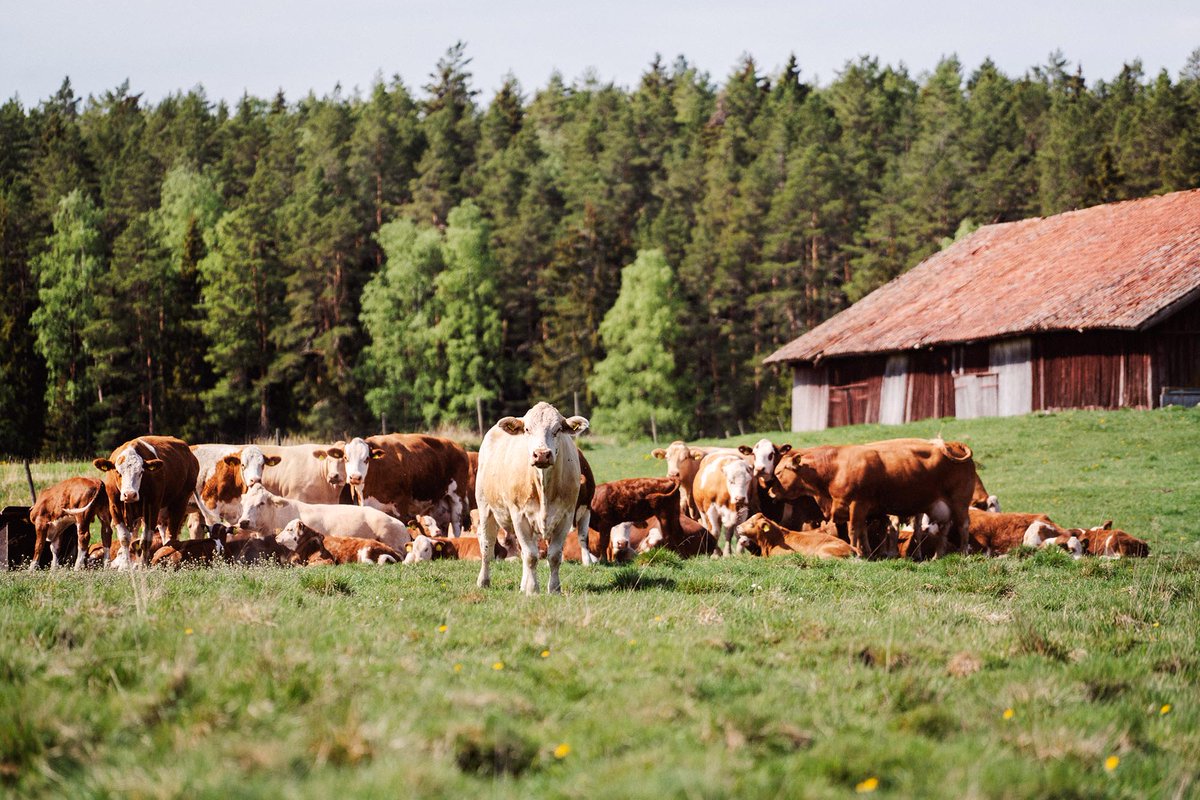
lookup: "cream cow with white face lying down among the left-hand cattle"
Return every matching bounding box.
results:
[238,483,412,551]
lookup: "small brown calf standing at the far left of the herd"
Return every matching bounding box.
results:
[29,477,113,570]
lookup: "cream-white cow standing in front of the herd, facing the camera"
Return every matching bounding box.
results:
[475,403,588,596]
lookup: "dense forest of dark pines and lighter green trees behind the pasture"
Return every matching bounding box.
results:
[0,43,1200,457]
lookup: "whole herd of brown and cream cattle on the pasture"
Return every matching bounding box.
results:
[21,403,1150,594]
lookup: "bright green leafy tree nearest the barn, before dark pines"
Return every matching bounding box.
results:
[589,249,686,438]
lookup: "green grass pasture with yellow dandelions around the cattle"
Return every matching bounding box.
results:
[0,409,1200,799]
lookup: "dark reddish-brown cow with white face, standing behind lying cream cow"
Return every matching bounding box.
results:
[343,433,470,536]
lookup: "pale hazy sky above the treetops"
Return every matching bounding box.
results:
[0,0,1200,107]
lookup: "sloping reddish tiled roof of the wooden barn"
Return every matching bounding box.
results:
[766,190,1200,363]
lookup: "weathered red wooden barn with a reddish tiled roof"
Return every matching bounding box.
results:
[766,190,1200,431]
